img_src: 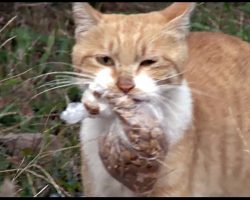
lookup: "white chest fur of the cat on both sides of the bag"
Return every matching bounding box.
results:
[80,80,192,197]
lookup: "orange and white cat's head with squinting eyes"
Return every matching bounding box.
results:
[72,3,195,98]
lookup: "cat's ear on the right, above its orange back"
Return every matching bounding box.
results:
[161,2,196,36]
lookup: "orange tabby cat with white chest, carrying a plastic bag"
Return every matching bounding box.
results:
[72,3,250,196]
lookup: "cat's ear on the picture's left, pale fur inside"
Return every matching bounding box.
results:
[73,2,102,37]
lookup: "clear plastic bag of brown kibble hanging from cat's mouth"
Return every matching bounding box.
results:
[99,96,167,195]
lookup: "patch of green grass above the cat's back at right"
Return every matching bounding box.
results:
[192,2,250,41]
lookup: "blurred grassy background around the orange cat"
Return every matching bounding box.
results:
[0,2,250,197]
